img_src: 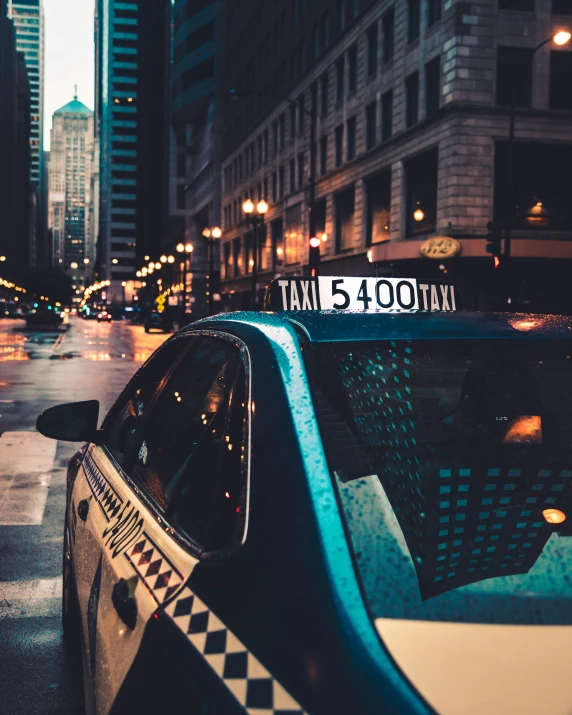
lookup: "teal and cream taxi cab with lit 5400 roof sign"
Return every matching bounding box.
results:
[34,276,572,715]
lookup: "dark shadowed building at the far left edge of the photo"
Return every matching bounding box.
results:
[0,0,35,279]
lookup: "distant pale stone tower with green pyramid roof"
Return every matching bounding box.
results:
[48,96,95,284]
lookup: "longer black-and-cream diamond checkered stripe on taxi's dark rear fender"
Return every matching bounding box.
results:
[165,586,305,715]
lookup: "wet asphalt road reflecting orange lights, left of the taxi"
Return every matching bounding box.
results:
[0,318,167,715]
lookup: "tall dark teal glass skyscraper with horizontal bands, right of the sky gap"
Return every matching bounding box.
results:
[95,0,171,300]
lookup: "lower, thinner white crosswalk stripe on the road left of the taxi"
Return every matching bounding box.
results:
[0,578,62,620]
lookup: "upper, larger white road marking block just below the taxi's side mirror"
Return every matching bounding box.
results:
[0,432,57,526]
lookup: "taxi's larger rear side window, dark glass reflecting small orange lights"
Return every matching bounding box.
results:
[129,338,245,550]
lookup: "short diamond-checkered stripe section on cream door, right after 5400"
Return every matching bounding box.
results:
[125,531,183,605]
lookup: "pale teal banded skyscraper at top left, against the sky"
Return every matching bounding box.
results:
[8,0,44,189]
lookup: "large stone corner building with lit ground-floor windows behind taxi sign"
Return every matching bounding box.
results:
[221,0,572,311]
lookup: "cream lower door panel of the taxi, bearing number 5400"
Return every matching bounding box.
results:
[81,446,197,715]
